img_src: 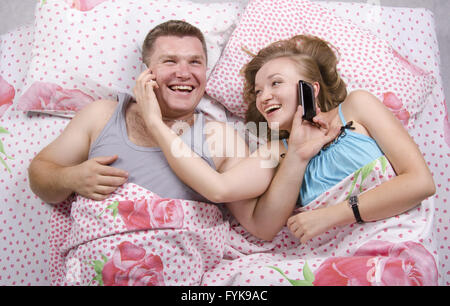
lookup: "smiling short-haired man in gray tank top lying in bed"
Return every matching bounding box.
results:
[29,21,336,240]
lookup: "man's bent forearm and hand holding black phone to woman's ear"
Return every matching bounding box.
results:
[227,109,339,240]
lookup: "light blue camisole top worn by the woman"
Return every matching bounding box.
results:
[283,104,384,206]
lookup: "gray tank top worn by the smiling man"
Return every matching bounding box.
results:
[89,94,215,202]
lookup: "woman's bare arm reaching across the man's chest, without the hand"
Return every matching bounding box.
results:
[149,120,275,203]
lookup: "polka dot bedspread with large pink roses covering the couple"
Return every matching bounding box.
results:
[50,156,439,286]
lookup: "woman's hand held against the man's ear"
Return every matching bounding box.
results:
[133,69,162,125]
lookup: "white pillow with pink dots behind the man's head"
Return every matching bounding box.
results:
[18,0,242,116]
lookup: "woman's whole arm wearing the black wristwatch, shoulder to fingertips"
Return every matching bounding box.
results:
[288,91,436,242]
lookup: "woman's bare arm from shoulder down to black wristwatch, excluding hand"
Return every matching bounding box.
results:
[344,91,436,221]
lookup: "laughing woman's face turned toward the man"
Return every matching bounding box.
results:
[255,57,304,131]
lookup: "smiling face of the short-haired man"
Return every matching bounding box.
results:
[149,36,206,118]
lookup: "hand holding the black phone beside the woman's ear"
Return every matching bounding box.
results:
[289,106,339,161]
